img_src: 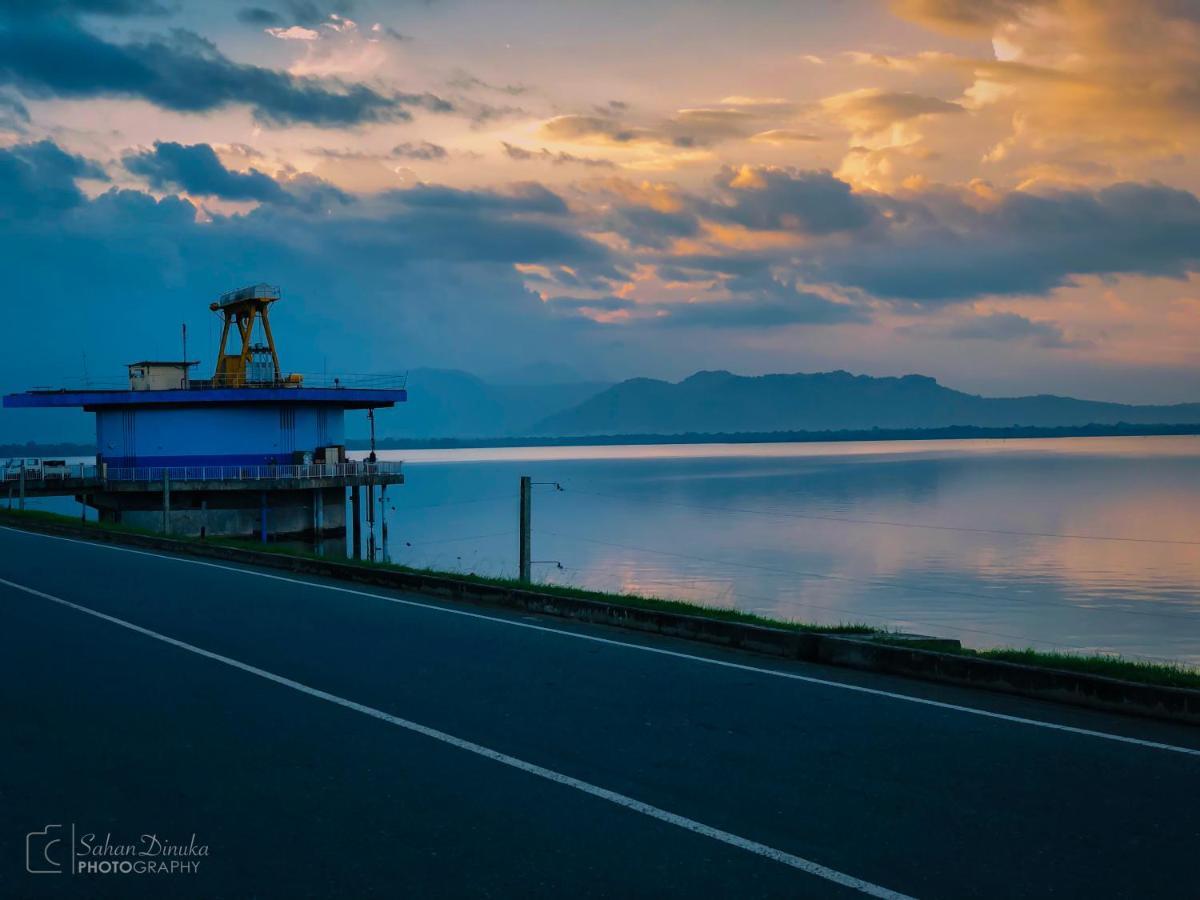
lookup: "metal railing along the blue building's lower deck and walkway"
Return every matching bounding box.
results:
[4,461,403,482]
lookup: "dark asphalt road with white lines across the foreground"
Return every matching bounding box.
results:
[0,528,1200,899]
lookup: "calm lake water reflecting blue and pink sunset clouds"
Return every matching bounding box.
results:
[362,437,1200,665]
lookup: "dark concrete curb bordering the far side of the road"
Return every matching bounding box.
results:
[9,515,1200,725]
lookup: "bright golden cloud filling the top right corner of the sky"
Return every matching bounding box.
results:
[892,0,1200,178]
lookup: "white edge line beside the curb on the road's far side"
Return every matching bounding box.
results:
[0,526,1200,756]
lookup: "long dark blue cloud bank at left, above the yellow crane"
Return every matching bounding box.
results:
[0,140,609,277]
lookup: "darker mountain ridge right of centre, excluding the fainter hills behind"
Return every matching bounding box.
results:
[528,372,1200,436]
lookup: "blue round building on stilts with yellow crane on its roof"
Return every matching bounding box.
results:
[4,284,407,548]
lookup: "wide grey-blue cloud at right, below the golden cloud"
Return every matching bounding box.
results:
[596,167,1200,309]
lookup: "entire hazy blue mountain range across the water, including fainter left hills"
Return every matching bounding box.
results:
[11,364,1200,457]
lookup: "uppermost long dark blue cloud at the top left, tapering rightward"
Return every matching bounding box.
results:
[0,19,451,127]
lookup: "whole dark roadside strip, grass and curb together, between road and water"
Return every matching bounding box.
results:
[0,510,1200,724]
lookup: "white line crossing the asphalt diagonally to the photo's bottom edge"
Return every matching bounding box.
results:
[0,578,912,900]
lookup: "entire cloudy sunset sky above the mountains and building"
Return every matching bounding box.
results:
[0,0,1200,444]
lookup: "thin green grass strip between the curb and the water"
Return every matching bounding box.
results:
[0,510,1200,690]
